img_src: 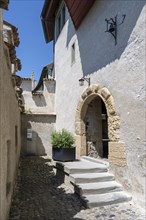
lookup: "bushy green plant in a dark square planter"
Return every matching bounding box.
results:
[51,129,75,162]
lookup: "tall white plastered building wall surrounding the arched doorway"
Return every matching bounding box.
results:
[55,0,146,205]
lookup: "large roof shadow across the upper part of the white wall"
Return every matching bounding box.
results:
[66,1,145,76]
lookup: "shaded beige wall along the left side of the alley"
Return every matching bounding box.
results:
[0,9,21,220]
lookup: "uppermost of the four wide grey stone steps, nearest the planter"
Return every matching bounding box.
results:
[63,161,107,174]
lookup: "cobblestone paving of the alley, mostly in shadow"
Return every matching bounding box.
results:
[9,156,145,220]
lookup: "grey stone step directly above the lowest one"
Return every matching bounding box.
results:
[75,181,122,196]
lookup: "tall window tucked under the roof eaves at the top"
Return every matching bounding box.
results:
[55,2,66,40]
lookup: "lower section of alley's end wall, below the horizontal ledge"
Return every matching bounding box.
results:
[21,114,56,157]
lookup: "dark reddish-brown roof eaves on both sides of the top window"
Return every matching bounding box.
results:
[41,0,95,43]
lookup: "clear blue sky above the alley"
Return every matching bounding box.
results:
[3,0,53,80]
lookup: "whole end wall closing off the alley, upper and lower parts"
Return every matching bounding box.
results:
[21,78,56,156]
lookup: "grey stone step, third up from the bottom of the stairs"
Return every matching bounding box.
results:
[70,172,115,184]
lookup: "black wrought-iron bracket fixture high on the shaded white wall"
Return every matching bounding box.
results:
[105,15,126,45]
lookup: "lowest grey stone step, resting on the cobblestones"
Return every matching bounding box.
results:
[81,191,132,208]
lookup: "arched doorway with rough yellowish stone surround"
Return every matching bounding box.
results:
[75,85,120,162]
